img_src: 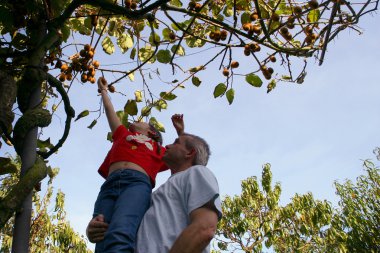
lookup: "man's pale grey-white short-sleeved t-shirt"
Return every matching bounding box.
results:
[137,165,221,253]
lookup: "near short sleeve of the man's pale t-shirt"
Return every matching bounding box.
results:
[185,166,222,219]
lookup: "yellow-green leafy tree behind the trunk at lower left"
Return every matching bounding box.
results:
[0,158,91,252]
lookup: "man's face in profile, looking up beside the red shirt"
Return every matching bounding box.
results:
[162,135,191,165]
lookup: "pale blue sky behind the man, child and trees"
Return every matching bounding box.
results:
[1,7,380,251]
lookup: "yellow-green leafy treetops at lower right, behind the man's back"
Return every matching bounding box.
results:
[214,153,380,253]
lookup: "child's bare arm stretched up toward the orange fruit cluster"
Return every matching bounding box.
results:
[98,77,121,133]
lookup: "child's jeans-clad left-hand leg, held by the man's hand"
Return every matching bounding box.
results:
[93,172,119,253]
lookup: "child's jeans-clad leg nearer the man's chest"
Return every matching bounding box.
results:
[104,170,152,253]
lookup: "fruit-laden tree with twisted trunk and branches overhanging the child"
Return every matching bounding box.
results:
[0,0,378,252]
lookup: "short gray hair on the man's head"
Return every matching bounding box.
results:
[183,133,211,166]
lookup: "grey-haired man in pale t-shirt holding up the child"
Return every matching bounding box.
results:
[87,119,221,253]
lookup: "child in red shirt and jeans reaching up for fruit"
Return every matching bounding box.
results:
[93,77,184,253]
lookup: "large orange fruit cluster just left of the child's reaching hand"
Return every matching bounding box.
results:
[56,44,100,83]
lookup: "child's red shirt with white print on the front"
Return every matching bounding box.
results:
[98,125,168,187]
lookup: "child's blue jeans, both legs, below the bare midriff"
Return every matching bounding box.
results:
[93,169,152,253]
